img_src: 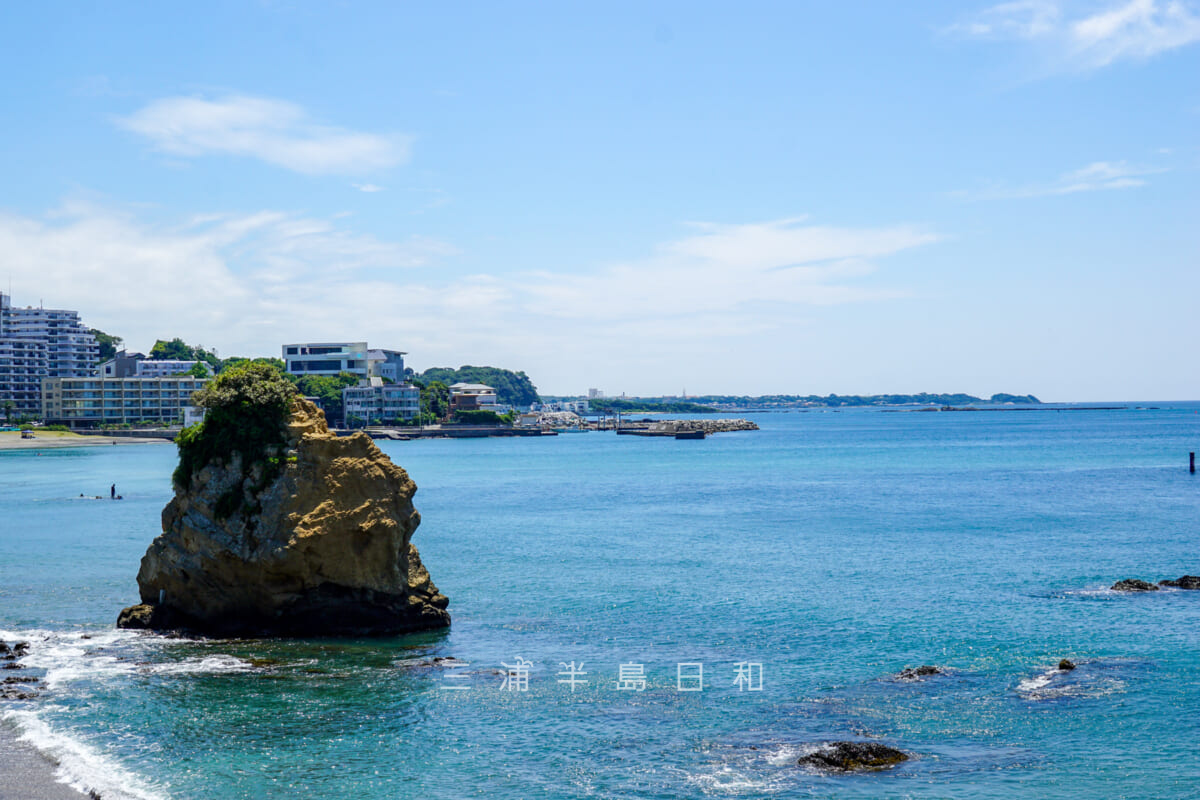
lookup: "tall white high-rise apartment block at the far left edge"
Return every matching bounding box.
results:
[0,293,100,415]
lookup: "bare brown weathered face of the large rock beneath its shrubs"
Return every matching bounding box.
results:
[118,399,450,636]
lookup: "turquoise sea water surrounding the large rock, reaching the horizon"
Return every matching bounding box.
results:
[0,404,1200,800]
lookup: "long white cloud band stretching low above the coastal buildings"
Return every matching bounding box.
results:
[0,201,938,387]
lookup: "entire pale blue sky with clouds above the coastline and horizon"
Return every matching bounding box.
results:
[0,0,1200,401]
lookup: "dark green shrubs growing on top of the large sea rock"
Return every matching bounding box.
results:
[173,363,296,501]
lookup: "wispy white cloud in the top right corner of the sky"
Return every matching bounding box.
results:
[948,0,1200,70]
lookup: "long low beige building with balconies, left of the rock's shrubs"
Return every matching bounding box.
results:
[41,375,208,427]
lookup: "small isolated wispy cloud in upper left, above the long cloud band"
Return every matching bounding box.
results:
[116,95,410,175]
